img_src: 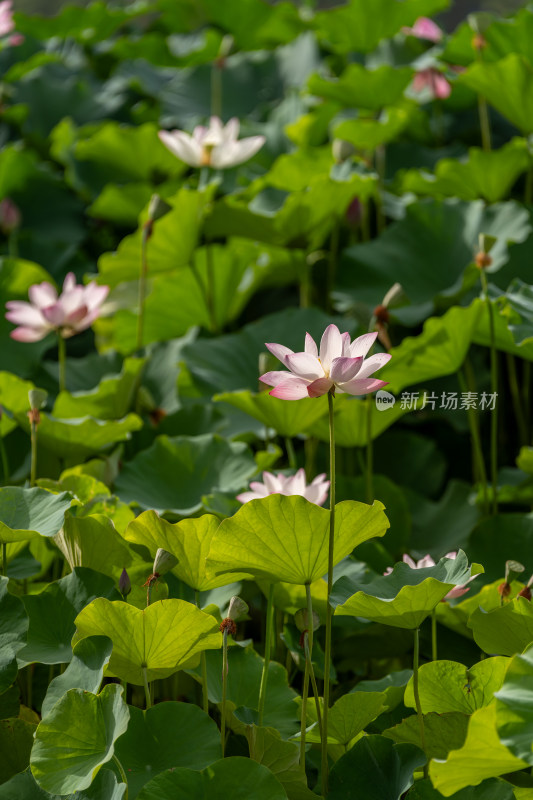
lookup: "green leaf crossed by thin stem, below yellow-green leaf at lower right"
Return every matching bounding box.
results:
[383,711,468,759]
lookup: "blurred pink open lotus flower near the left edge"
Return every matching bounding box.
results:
[6,272,109,342]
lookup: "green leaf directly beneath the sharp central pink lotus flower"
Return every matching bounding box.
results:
[213,391,328,444]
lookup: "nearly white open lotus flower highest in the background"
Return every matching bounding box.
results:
[159,117,265,169]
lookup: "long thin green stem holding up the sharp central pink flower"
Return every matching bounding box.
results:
[321,391,335,797]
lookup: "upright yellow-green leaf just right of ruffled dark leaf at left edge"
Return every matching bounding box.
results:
[55,514,133,579]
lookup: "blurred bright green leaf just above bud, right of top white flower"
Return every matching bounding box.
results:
[334,101,417,150]
